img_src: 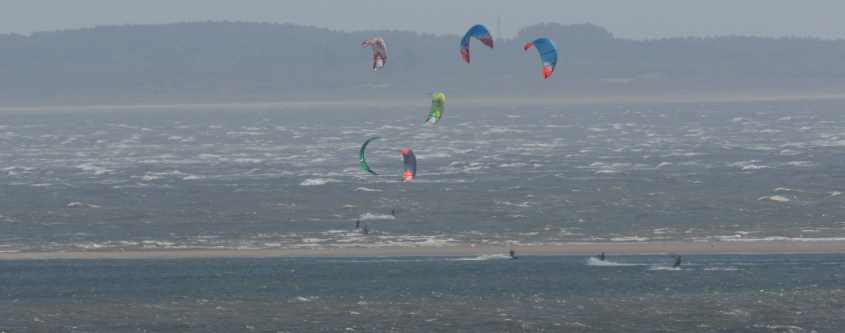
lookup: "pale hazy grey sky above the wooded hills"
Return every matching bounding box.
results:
[0,0,845,39]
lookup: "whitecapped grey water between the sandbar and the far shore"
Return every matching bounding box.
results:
[0,102,845,251]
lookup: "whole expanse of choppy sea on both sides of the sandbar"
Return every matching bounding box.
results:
[0,98,845,332]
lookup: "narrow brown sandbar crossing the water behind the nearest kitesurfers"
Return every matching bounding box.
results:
[0,241,845,260]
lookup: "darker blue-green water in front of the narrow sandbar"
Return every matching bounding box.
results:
[0,255,845,332]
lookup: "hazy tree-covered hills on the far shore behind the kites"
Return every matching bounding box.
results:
[0,22,845,104]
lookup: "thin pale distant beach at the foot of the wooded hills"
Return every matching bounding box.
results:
[0,92,845,112]
